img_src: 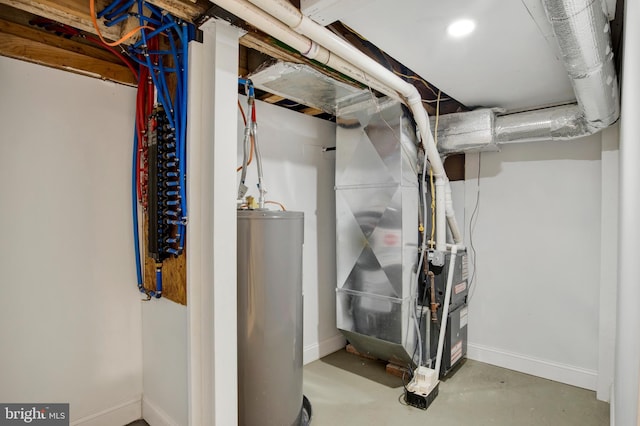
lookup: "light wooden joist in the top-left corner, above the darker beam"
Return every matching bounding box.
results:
[0,0,120,40]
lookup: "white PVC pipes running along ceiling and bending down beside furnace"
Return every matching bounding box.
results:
[214,0,462,251]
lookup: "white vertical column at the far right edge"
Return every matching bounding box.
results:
[611,0,640,426]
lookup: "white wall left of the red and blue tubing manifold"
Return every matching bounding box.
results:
[0,57,142,425]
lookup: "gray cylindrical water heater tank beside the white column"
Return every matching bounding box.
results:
[238,210,308,426]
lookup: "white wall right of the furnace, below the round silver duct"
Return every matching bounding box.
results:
[465,134,601,389]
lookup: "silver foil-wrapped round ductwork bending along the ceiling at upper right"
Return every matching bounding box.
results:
[438,0,620,154]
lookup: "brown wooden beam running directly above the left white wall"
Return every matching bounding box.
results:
[0,27,136,85]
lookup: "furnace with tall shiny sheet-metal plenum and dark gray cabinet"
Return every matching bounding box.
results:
[335,98,468,375]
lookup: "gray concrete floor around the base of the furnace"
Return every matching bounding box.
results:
[304,351,609,426]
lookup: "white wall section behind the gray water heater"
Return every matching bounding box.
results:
[238,97,345,364]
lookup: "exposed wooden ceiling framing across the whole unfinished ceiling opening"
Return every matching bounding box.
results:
[0,0,464,118]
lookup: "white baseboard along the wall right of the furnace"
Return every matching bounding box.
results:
[467,343,598,390]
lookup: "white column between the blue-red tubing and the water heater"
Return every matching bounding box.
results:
[187,21,240,426]
